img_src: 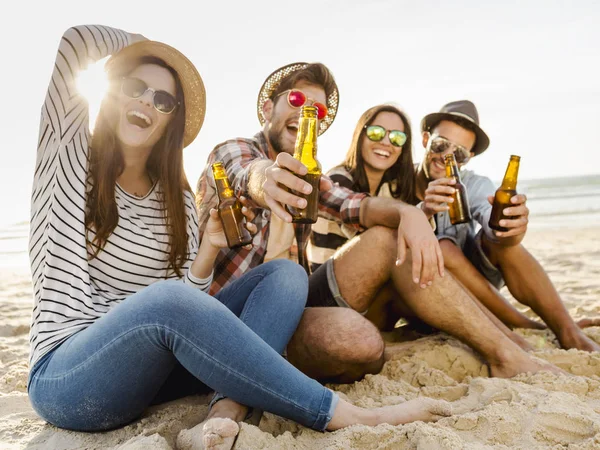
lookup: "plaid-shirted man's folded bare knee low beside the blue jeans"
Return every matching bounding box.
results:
[287,308,384,383]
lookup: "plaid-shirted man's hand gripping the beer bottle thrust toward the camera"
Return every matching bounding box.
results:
[263,153,332,222]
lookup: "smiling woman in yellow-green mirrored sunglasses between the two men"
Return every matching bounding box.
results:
[308,105,417,271]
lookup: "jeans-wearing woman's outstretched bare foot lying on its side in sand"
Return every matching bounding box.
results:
[375,397,452,425]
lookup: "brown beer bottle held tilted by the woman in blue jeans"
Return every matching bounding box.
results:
[212,161,252,248]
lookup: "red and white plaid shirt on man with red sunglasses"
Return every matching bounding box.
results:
[196,131,367,293]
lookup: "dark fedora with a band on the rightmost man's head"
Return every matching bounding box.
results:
[421,100,490,155]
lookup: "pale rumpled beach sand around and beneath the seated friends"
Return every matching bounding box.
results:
[0,228,600,450]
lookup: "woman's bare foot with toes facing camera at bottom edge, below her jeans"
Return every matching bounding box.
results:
[177,398,248,450]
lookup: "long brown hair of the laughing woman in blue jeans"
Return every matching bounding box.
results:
[85,57,191,276]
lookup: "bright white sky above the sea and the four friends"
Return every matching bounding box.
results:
[0,0,600,229]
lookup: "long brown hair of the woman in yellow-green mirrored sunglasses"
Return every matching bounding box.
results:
[343,104,418,204]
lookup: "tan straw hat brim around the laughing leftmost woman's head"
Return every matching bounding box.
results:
[104,41,206,147]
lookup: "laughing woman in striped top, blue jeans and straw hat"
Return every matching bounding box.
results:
[28,26,450,448]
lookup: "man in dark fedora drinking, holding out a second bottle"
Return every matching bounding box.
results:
[417,100,600,351]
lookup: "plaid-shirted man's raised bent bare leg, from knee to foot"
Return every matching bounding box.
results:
[334,227,559,378]
